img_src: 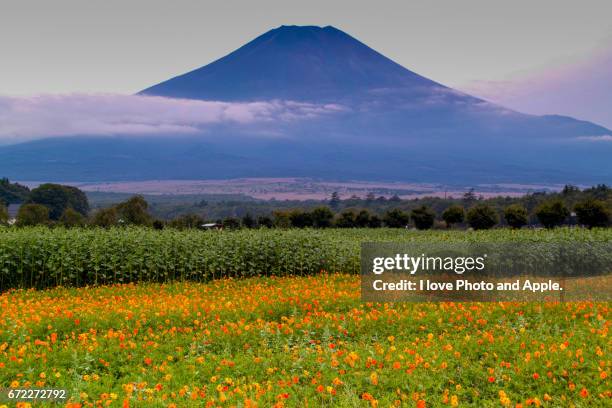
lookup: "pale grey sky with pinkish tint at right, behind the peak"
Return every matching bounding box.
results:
[0,0,612,127]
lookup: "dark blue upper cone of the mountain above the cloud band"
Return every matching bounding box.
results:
[141,26,452,102]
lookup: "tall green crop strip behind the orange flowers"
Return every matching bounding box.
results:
[0,227,612,290]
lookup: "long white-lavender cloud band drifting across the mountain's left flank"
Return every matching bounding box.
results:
[0,94,344,144]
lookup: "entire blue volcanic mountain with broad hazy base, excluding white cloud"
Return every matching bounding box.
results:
[0,26,612,185]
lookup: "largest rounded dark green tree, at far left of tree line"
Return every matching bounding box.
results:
[27,183,89,220]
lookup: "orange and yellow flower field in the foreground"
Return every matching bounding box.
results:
[0,273,612,407]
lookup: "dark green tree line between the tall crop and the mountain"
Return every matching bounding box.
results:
[0,179,612,230]
